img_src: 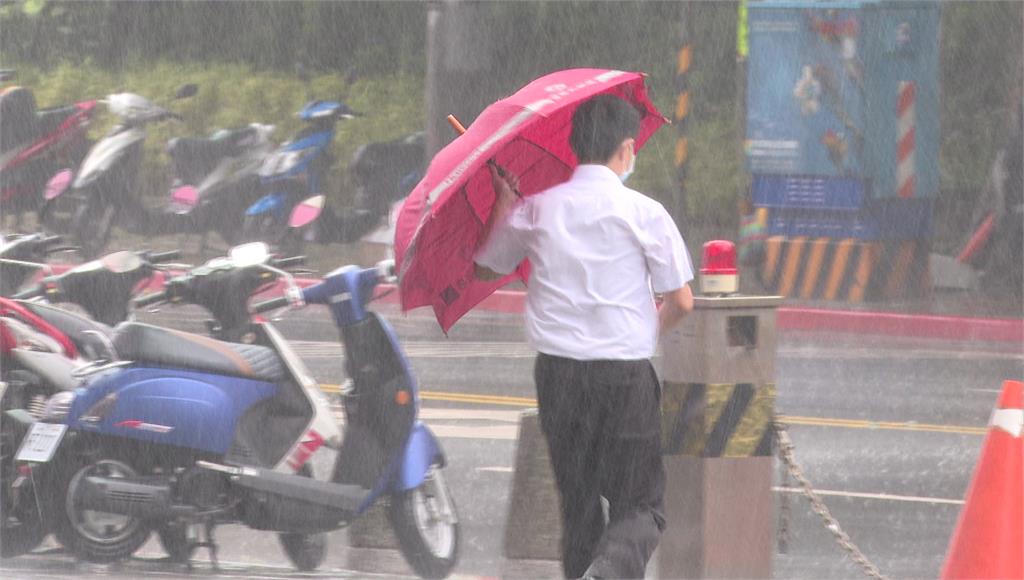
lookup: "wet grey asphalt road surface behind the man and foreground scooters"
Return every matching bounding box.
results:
[0,307,1024,578]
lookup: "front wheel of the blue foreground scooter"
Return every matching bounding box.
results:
[388,465,459,578]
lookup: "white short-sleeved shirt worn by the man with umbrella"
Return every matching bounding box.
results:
[475,165,693,361]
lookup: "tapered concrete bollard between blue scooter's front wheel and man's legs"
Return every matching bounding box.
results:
[505,410,562,561]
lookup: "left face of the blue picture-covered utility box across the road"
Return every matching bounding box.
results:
[746,3,864,176]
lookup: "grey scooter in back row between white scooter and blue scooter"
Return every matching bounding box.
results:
[160,123,274,253]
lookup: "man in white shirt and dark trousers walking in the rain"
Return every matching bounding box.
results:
[475,95,693,578]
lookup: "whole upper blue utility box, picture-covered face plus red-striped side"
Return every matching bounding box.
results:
[745,0,939,201]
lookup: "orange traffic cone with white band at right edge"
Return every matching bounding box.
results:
[942,380,1024,579]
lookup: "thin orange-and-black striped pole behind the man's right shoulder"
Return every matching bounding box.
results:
[672,2,693,226]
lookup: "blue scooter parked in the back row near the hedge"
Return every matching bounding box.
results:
[243,100,358,250]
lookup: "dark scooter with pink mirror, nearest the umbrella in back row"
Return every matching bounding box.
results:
[288,132,426,250]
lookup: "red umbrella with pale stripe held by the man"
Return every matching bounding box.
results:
[394,69,668,332]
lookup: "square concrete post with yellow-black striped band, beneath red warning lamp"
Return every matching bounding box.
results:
[657,296,781,578]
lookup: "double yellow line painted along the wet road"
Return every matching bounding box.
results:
[321,384,988,436]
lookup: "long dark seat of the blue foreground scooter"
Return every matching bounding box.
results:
[114,323,289,382]
